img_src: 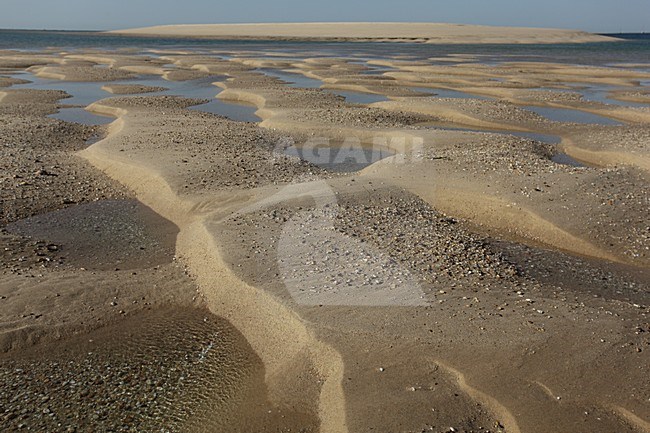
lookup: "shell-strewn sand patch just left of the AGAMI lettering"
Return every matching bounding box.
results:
[96,96,328,193]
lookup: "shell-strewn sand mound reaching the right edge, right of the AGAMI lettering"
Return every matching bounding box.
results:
[423,134,650,264]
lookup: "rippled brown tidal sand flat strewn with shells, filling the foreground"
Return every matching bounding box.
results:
[0,48,650,433]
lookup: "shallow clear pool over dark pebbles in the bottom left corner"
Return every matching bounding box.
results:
[0,306,276,432]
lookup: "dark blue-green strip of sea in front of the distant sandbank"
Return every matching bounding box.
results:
[0,30,650,70]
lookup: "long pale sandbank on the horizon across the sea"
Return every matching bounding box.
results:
[111,23,616,44]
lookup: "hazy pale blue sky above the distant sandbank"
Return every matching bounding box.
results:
[0,0,650,33]
